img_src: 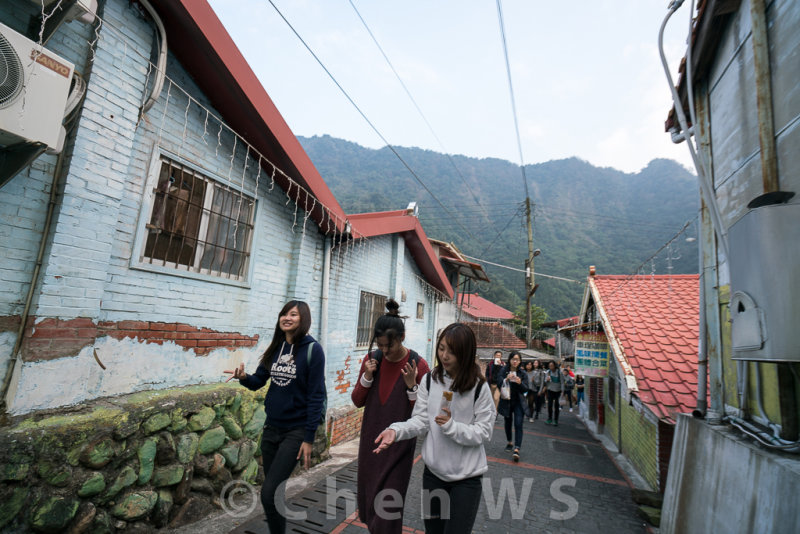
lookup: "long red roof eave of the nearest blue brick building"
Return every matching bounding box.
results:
[153,0,345,231]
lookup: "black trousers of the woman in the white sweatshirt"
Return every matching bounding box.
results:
[422,467,483,534]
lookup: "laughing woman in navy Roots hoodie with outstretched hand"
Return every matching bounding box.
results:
[225,300,326,534]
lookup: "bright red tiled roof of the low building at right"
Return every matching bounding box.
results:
[589,274,699,420]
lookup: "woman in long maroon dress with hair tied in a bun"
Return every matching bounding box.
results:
[351,299,430,534]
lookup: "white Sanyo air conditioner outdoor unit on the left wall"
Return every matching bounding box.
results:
[0,24,75,152]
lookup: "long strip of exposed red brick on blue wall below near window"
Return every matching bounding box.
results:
[18,317,258,361]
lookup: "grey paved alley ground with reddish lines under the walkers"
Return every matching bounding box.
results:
[180,409,657,534]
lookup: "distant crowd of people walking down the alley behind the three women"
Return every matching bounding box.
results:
[485,350,584,462]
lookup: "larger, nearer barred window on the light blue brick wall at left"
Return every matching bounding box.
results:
[141,155,255,281]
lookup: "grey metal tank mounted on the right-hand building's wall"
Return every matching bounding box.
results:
[728,204,800,362]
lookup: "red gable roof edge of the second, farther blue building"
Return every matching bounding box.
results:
[347,210,453,298]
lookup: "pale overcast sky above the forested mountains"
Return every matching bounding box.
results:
[209,0,694,172]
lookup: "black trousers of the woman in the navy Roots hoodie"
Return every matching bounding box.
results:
[261,425,304,534]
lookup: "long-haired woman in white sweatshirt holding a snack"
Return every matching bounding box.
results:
[374,323,496,534]
